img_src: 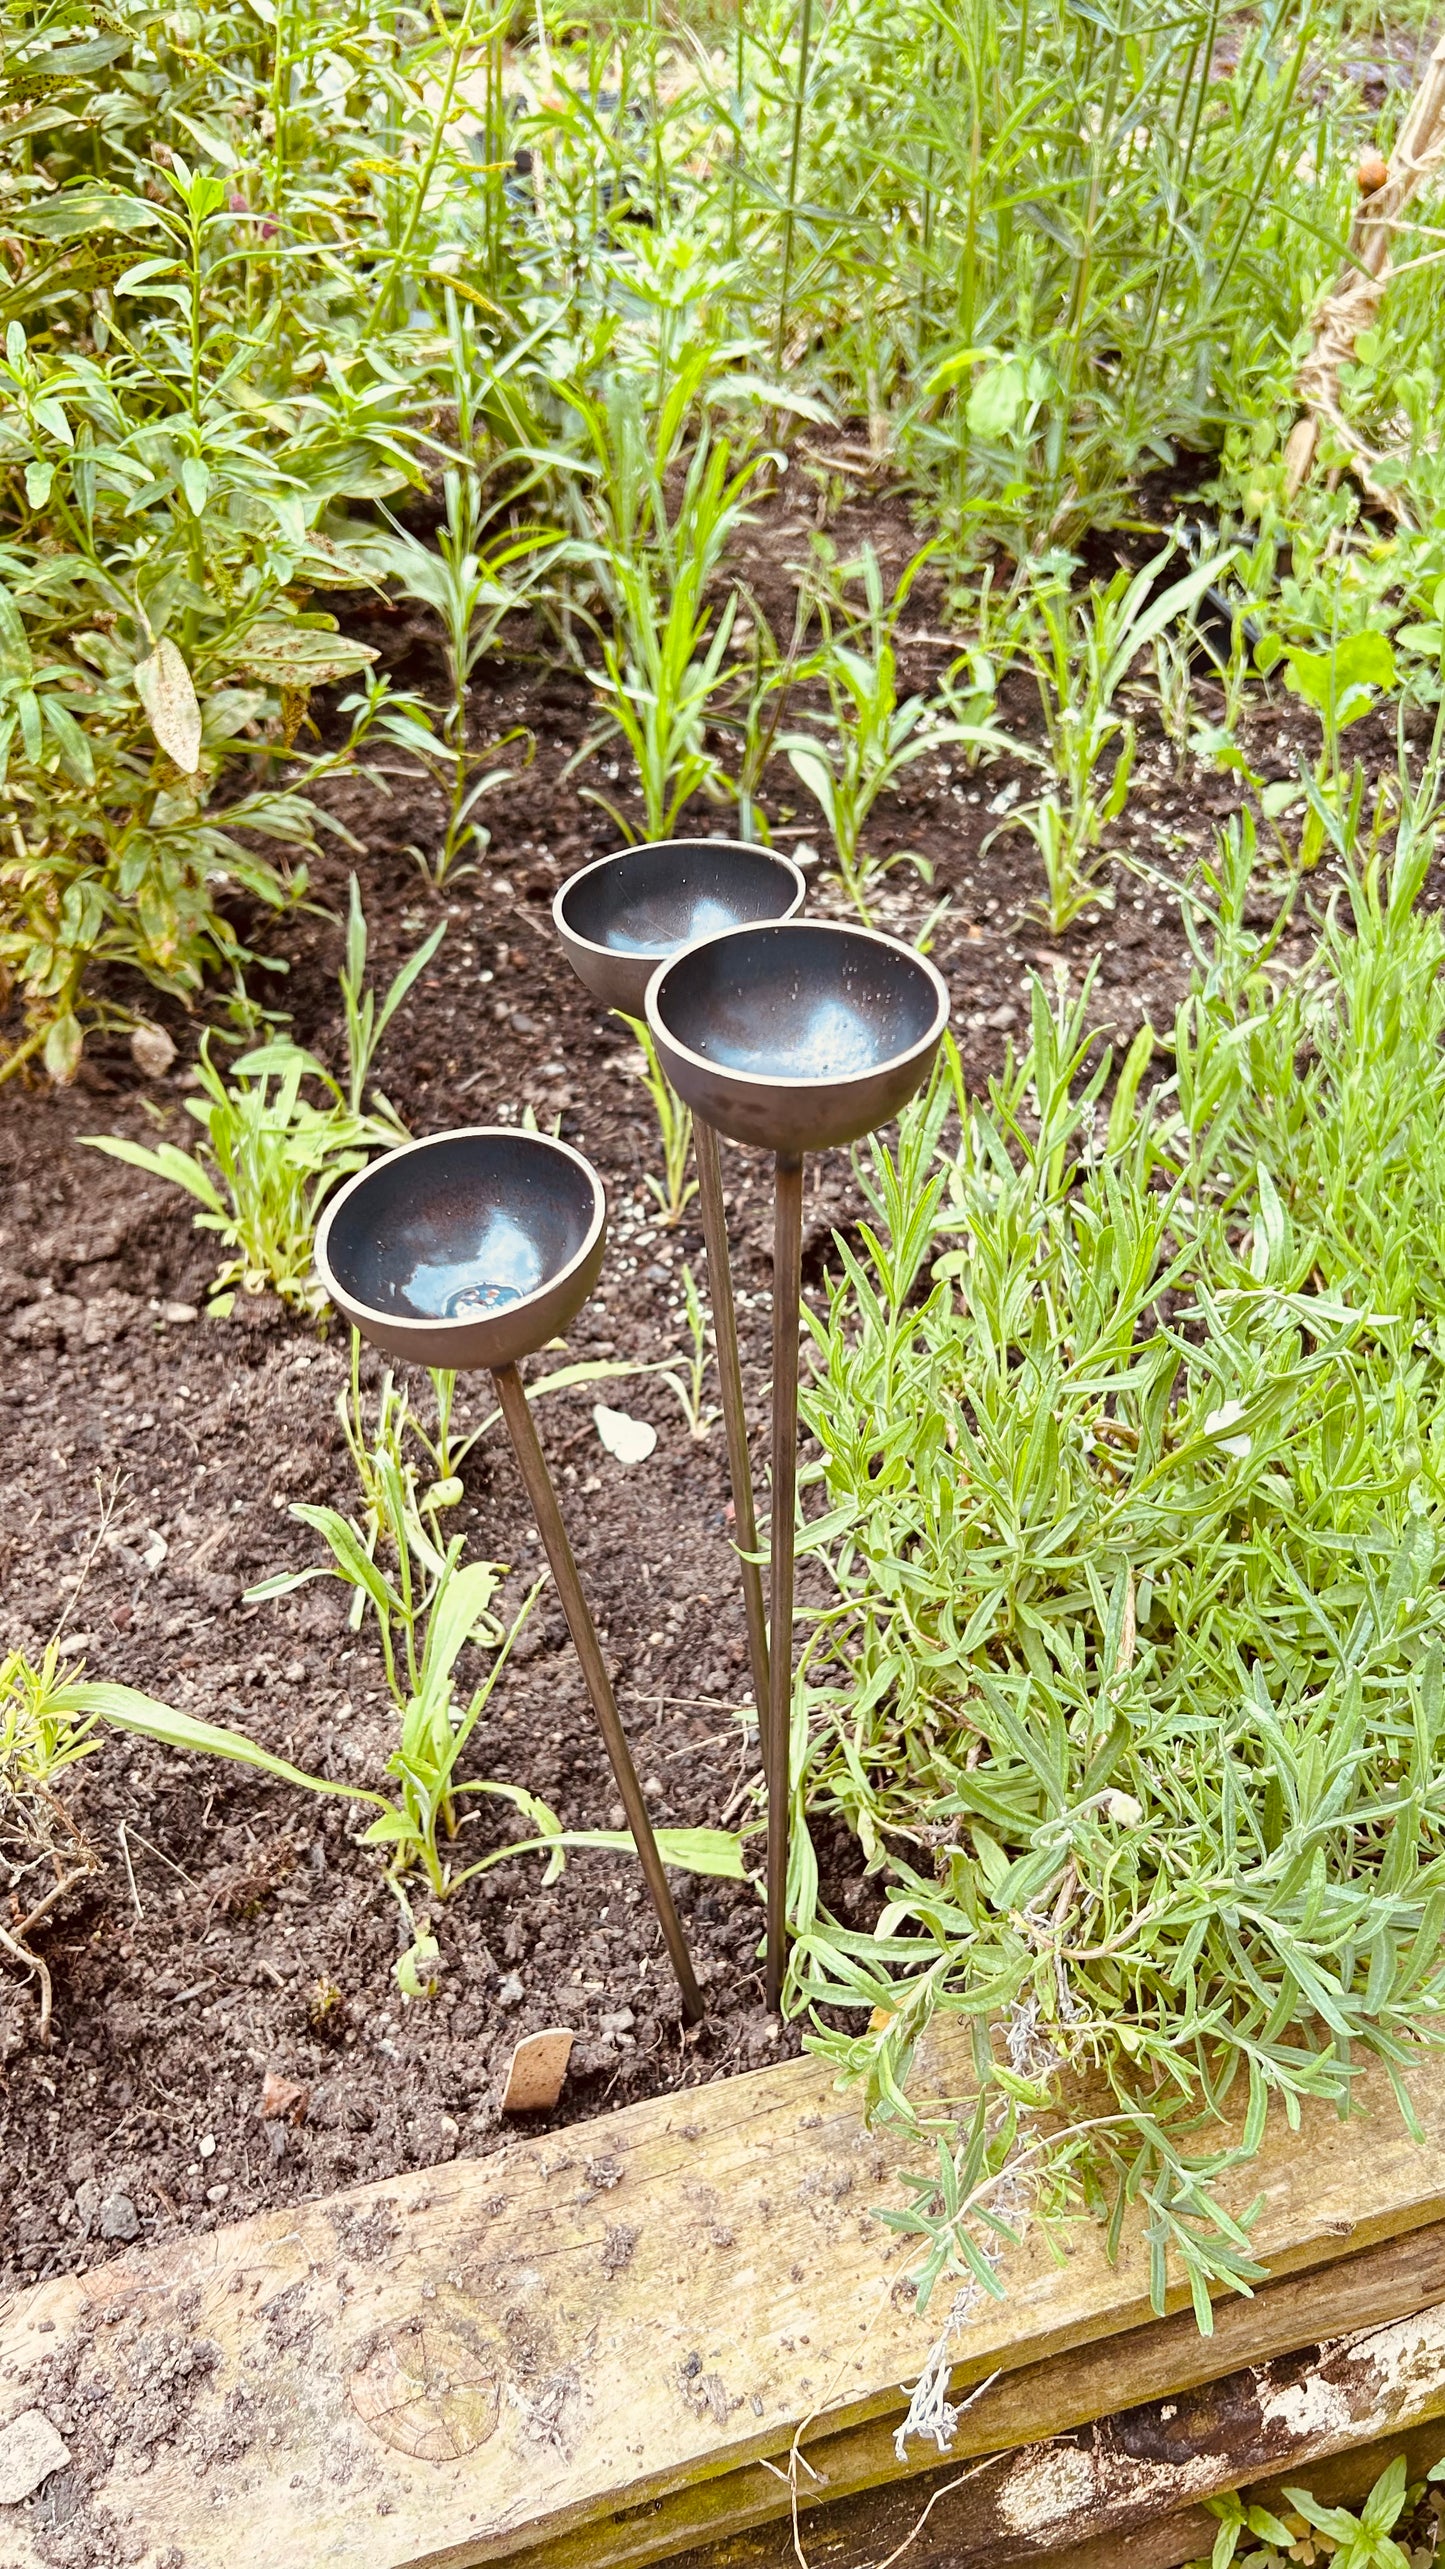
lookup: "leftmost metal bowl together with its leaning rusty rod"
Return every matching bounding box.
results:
[316,1125,705,2024]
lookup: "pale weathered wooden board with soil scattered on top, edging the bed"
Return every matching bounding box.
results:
[0,2053,1445,2569]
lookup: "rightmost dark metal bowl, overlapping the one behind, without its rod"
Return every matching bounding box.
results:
[645,920,949,1151]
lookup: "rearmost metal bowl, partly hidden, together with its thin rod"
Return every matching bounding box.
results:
[553,837,807,1736]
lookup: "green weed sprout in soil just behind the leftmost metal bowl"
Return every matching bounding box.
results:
[85,876,431,1320]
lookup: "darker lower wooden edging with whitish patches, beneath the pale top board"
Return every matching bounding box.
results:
[653,2222,1445,2569]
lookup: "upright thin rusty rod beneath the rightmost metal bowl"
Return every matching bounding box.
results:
[766,1151,802,2014]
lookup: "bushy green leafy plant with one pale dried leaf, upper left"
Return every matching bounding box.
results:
[0,0,545,1079]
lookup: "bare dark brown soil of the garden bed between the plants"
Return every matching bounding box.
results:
[0,475,1388,2279]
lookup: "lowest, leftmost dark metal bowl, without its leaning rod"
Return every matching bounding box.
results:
[316,1125,607,1369]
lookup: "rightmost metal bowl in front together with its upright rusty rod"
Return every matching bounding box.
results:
[645,920,949,2009]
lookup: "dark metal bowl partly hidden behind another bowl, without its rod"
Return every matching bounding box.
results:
[553,837,807,1017]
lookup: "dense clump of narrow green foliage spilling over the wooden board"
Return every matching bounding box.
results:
[792,830,1445,2328]
